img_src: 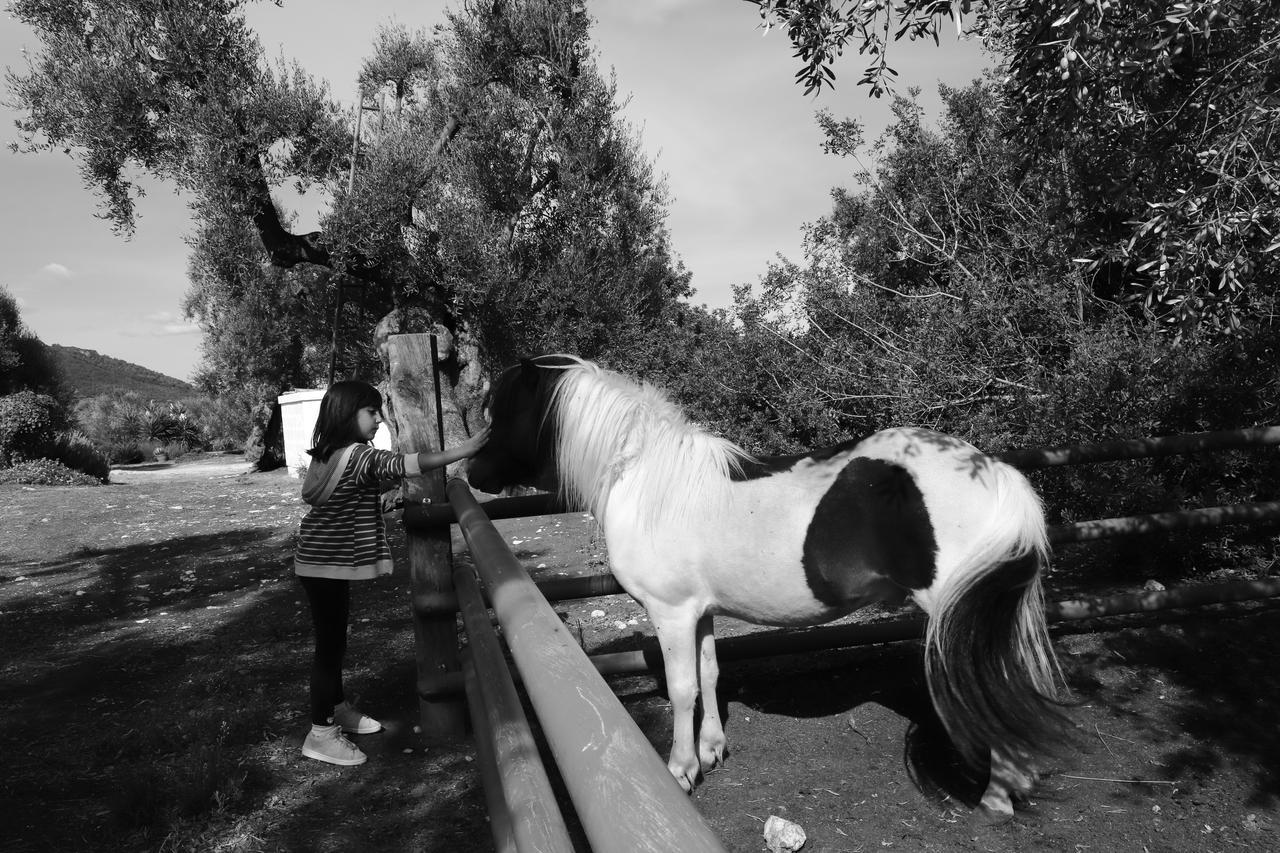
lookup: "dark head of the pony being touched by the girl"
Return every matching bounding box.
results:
[467,355,580,494]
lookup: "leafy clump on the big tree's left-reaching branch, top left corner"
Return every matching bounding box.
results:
[9,0,339,231]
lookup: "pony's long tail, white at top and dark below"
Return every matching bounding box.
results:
[924,462,1071,767]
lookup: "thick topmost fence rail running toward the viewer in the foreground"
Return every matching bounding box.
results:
[448,479,724,853]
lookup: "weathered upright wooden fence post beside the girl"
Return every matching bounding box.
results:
[387,334,466,743]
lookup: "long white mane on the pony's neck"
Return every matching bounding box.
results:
[549,356,748,526]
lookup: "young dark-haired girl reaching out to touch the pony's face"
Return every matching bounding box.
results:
[293,380,489,766]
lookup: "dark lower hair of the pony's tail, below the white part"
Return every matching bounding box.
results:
[924,553,1071,766]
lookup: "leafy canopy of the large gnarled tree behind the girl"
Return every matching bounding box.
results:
[9,0,711,445]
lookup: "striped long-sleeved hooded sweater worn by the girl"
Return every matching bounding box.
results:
[293,444,421,580]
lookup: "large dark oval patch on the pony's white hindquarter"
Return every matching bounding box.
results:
[803,456,938,607]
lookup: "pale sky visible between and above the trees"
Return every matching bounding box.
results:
[0,0,988,379]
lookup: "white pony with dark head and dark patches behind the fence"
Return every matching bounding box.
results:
[467,355,1070,822]
